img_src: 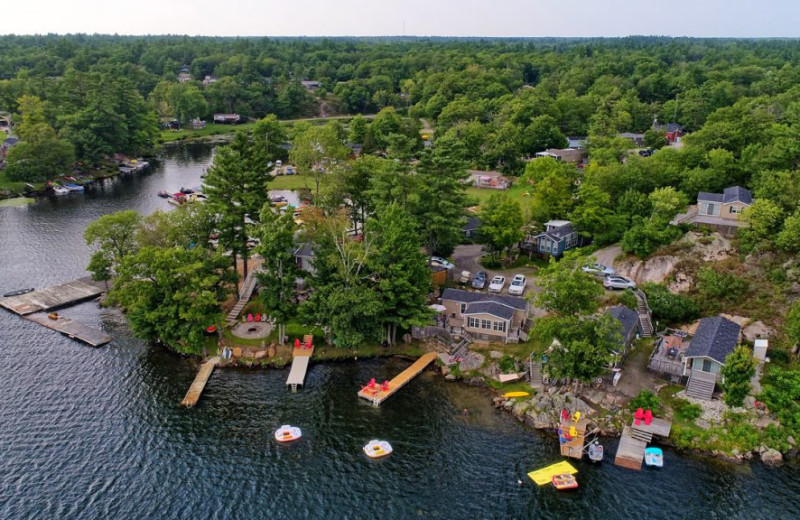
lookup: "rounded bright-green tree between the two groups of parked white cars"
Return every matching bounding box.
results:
[536,251,603,316]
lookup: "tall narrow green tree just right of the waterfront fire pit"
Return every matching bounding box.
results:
[256,205,299,345]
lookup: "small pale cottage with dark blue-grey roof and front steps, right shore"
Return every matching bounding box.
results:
[683,316,741,399]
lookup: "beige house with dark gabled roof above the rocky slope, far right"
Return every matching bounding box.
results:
[672,186,753,235]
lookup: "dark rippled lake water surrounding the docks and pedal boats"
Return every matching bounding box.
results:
[0,145,800,520]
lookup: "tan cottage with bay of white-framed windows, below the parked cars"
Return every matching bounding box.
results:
[442,289,530,343]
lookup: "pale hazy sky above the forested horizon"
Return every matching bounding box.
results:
[0,0,800,37]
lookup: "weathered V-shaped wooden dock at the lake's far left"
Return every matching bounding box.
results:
[0,278,112,347]
